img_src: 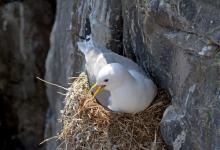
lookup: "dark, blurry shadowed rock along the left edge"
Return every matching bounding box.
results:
[0,0,53,150]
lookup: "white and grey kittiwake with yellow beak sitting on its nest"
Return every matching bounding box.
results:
[77,37,157,113]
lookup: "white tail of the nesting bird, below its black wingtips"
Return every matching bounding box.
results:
[77,35,94,55]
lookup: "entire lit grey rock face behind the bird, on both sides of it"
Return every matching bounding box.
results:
[46,0,220,150]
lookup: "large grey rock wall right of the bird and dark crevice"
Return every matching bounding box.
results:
[122,0,220,150]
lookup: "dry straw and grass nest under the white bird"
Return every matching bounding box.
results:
[58,73,169,150]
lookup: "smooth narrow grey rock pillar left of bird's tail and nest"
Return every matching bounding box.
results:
[45,0,83,150]
